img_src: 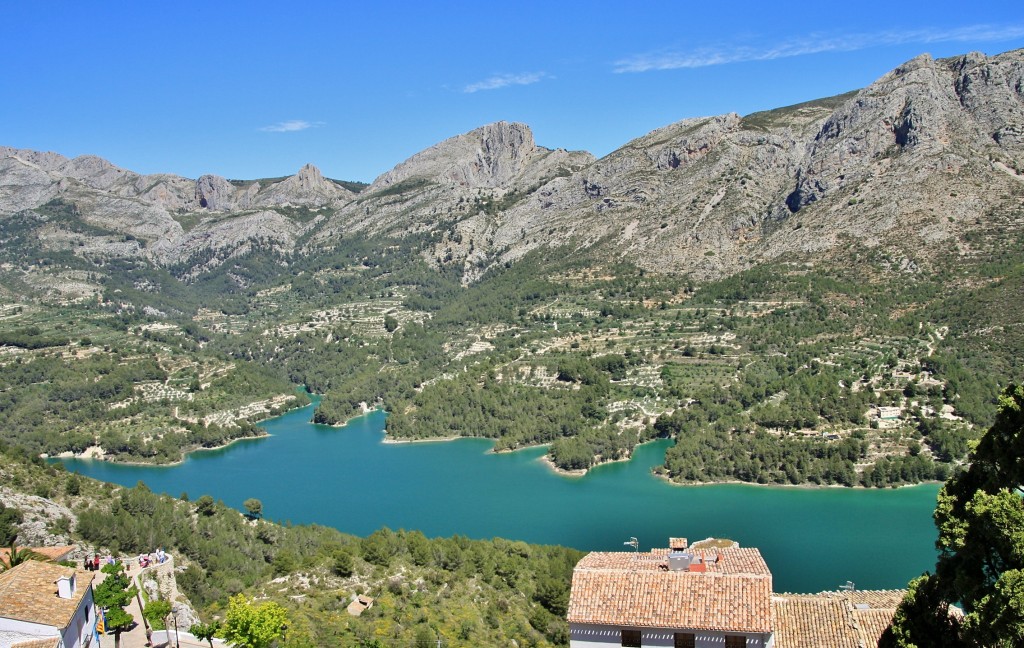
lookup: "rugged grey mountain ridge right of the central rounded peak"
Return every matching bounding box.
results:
[403,45,1024,277]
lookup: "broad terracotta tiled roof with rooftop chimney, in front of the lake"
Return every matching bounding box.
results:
[568,549,772,633]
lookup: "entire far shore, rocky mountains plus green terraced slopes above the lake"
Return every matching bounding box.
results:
[0,51,1024,486]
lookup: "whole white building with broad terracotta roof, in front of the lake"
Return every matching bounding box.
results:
[567,538,775,648]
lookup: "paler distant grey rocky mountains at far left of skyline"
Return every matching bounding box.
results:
[0,147,353,276]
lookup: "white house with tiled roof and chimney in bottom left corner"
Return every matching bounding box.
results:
[0,560,96,648]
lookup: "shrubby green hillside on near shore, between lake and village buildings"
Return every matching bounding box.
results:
[0,444,583,648]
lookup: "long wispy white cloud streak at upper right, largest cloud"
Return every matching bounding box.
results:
[612,25,1024,73]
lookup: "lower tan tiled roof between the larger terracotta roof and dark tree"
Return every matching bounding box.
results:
[772,590,904,648]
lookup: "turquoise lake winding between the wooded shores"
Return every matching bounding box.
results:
[62,405,938,592]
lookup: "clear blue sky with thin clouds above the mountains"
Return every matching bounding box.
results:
[0,0,1024,181]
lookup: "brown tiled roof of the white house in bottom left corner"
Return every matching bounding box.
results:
[0,560,93,628]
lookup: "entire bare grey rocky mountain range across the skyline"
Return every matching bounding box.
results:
[0,50,1024,288]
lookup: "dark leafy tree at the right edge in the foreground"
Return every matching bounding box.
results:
[887,386,1024,648]
